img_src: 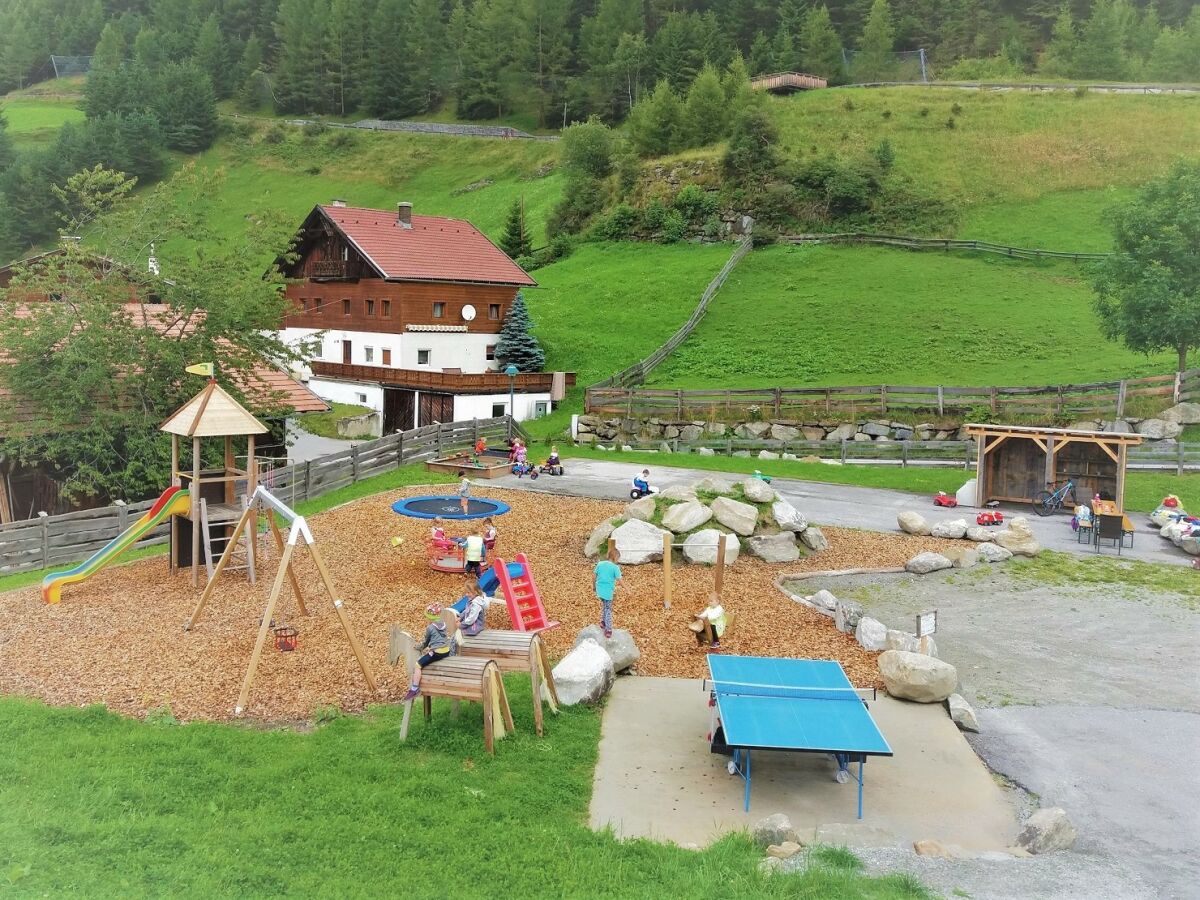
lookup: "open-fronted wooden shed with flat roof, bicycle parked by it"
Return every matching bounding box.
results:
[966,425,1141,509]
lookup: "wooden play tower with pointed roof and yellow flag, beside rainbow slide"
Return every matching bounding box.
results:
[160,378,268,587]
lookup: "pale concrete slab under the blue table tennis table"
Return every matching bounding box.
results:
[590,678,1018,851]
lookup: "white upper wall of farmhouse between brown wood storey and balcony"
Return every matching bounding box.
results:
[281,328,499,374]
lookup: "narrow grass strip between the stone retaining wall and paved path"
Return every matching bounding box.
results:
[556,443,1200,512]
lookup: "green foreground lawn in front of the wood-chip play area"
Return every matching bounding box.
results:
[0,700,929,900]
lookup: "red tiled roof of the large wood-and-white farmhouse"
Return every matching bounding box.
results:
[318,206,538,287]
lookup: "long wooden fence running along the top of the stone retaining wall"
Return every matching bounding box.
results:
[586,368,1200,421]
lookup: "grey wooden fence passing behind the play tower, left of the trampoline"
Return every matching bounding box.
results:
[0,416,523,575]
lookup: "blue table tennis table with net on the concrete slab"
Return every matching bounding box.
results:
[708,654,893,818]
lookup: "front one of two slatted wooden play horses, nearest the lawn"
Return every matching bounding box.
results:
[388,625,512,754]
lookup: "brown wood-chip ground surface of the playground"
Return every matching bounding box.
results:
[0,487,964,721]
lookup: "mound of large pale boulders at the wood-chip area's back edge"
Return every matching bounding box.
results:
[583,475,829,565]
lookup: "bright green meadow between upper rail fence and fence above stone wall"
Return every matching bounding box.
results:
[650,246,1174,388]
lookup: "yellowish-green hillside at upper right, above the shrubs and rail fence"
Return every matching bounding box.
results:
[772,88,1200,244]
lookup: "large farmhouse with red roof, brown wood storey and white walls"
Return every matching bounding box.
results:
[281,200,574,433]
